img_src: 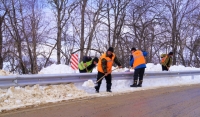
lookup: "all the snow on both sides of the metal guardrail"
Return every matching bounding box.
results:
[0,63,200,112]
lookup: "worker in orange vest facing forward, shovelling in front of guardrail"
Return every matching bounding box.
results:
[95,47,122,93]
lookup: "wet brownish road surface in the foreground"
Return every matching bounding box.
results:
[0,85,200,117]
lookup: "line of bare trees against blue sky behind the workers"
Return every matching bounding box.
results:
[0,0,200,74]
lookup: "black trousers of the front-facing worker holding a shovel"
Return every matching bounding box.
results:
[96,72,112,91]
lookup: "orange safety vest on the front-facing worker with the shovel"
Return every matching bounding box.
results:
[97,53,115,73]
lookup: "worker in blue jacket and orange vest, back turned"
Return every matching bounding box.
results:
[130,47,148,87]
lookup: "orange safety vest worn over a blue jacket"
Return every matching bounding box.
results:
[133,50,146,68]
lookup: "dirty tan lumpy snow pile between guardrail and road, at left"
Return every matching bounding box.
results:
[0,84,88,112]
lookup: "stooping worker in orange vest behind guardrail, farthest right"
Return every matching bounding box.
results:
[160,52,173,71]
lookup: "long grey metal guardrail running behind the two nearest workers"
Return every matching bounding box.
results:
[0,70,200,88]
